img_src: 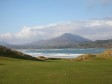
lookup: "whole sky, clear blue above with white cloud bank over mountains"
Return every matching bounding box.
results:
[0,0,112,44]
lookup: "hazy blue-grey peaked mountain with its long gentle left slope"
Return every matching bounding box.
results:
[15,33,91,48]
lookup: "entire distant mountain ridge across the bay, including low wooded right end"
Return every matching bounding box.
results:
[1,33,112,49]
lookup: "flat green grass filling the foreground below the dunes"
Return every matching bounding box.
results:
[0,57,112,84]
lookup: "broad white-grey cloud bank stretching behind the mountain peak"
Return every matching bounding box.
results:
[0,19,112,44]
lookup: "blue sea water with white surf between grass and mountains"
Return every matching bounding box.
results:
[17,48,105,58]
